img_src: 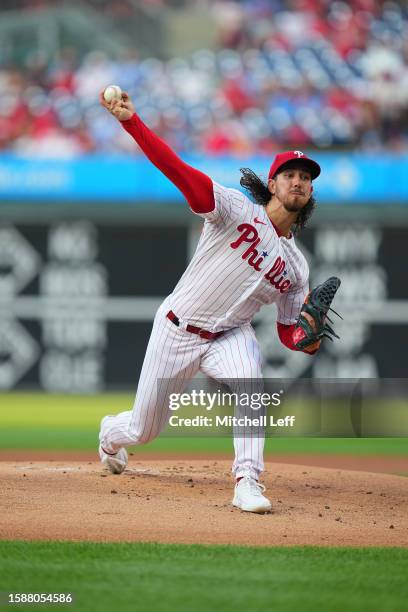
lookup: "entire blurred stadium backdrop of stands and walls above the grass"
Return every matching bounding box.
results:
[0,0,408,406]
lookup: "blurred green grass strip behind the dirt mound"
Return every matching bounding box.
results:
[0,393,408,455]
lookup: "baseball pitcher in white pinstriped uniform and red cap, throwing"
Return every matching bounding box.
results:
[99,93,340,513]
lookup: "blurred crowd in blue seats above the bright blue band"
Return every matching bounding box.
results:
[0,0,408,156]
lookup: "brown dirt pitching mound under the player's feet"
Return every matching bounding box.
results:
[0,459,408,546]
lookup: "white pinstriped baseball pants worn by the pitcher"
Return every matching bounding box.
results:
[99,300,264,478]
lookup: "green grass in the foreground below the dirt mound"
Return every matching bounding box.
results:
[0,542,408,612]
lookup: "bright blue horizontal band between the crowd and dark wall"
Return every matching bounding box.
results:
[0,151,408,208]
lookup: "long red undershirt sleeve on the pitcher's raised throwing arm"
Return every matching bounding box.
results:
[121,113,215,213]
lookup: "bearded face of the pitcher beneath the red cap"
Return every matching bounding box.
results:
[268,168,313,212]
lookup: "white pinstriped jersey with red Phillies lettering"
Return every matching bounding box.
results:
[169,183,309,331]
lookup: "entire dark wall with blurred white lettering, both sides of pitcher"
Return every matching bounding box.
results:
[0,219,408,393]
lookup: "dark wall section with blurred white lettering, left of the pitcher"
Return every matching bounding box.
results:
[0,220,187,393]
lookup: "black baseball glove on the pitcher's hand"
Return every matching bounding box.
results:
[293,276,342,353]
